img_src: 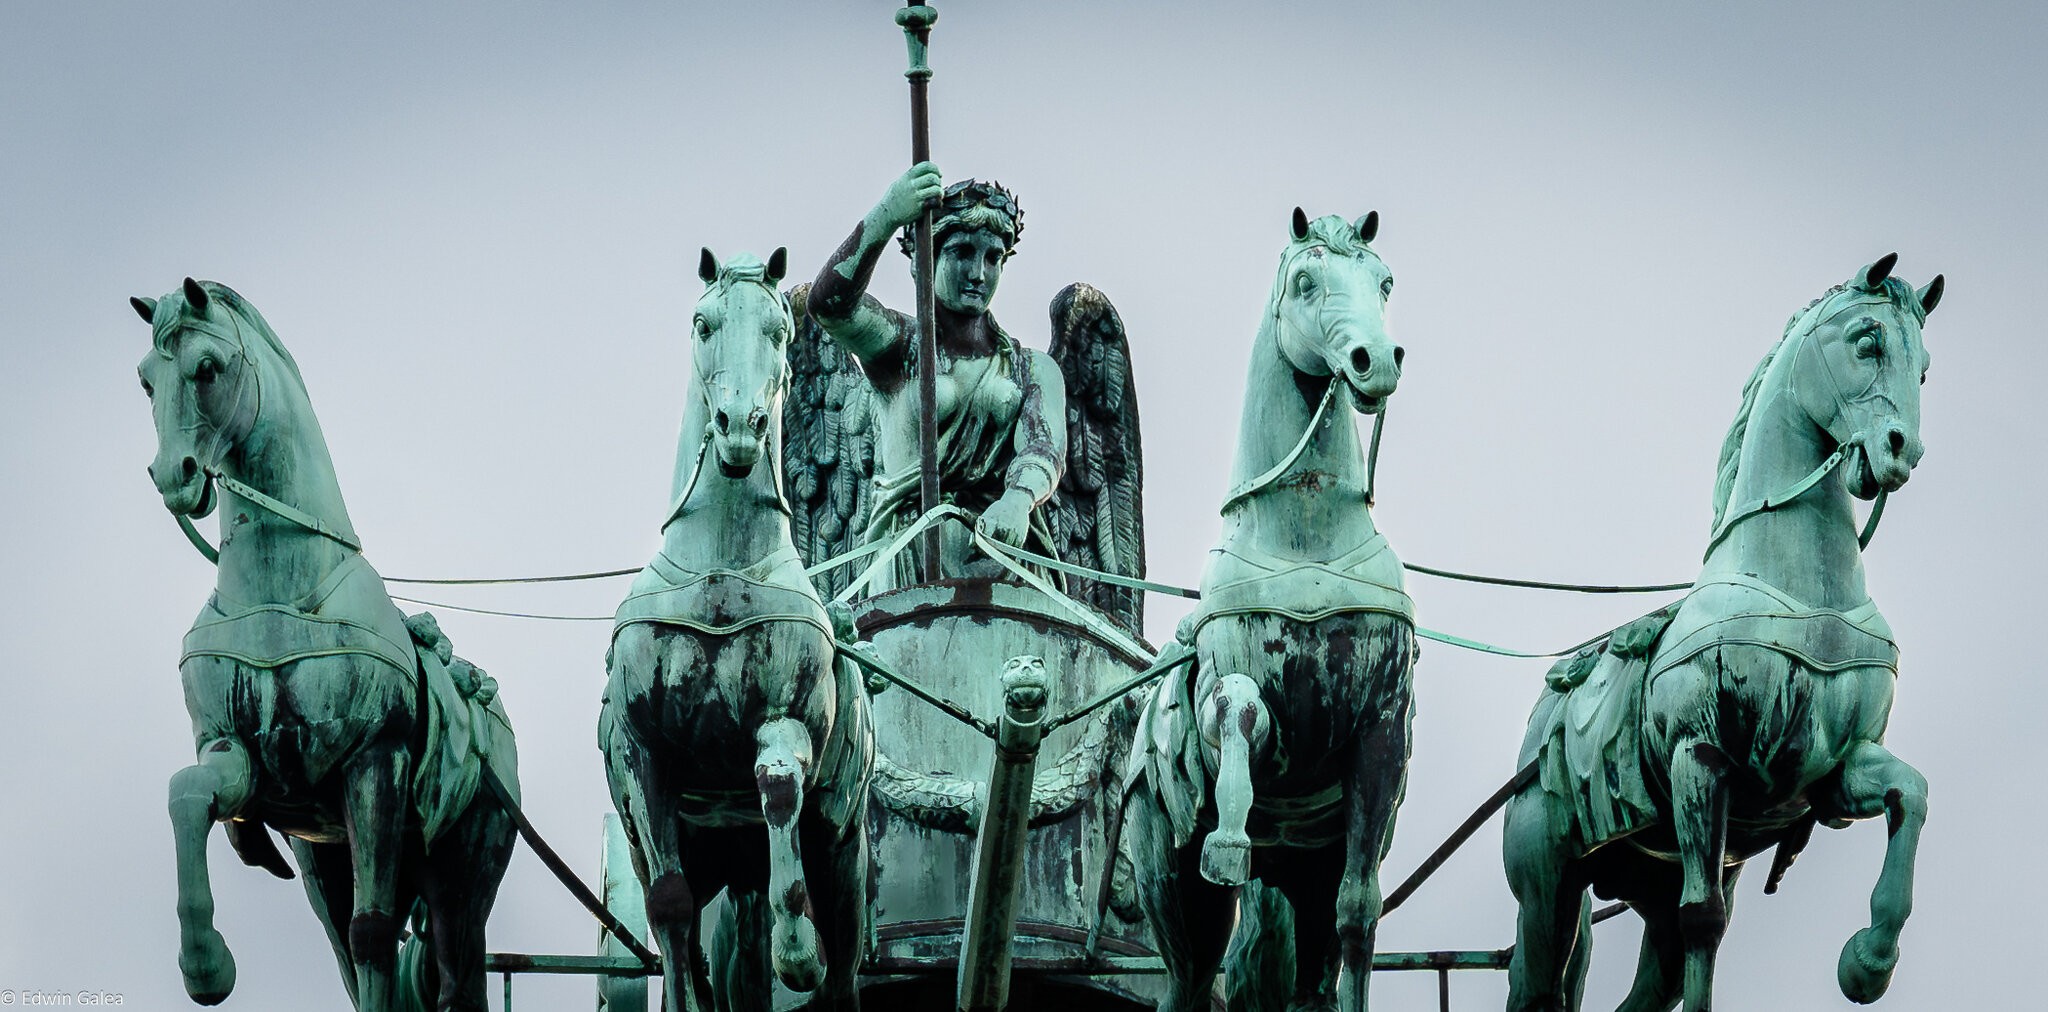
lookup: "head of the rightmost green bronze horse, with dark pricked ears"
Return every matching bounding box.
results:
[1786,254,1944,500]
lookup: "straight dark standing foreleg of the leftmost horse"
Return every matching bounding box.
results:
[342,744,412,1012]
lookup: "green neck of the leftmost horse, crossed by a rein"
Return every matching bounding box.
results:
[215,356,354,604]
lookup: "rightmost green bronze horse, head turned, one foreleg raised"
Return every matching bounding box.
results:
[1505,254,1944,1012]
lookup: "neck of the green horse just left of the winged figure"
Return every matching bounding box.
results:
[662,383,797,572]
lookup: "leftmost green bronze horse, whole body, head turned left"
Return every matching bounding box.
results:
[131,279,518,1012]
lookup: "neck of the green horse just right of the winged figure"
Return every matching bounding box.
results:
[1225,309,1372,553]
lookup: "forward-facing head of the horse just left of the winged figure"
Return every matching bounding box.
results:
[690,248,795,477]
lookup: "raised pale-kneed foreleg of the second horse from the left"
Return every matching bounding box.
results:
[754,717,825,992]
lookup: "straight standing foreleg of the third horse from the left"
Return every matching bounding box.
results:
[1337,701,1409,1012]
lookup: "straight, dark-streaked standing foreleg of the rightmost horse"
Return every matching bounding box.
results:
[1671,742,1729,1012]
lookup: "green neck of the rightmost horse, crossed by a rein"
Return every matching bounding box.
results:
[1702,348,1870,608]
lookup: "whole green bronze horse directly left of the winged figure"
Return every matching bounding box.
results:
[598,250,874,1012]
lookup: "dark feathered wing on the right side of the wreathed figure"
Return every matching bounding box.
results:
[1049,283,1145,633]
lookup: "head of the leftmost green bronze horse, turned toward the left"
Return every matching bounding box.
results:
[129,279,268,516]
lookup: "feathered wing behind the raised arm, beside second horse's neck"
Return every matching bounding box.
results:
[782,285,874,596]
